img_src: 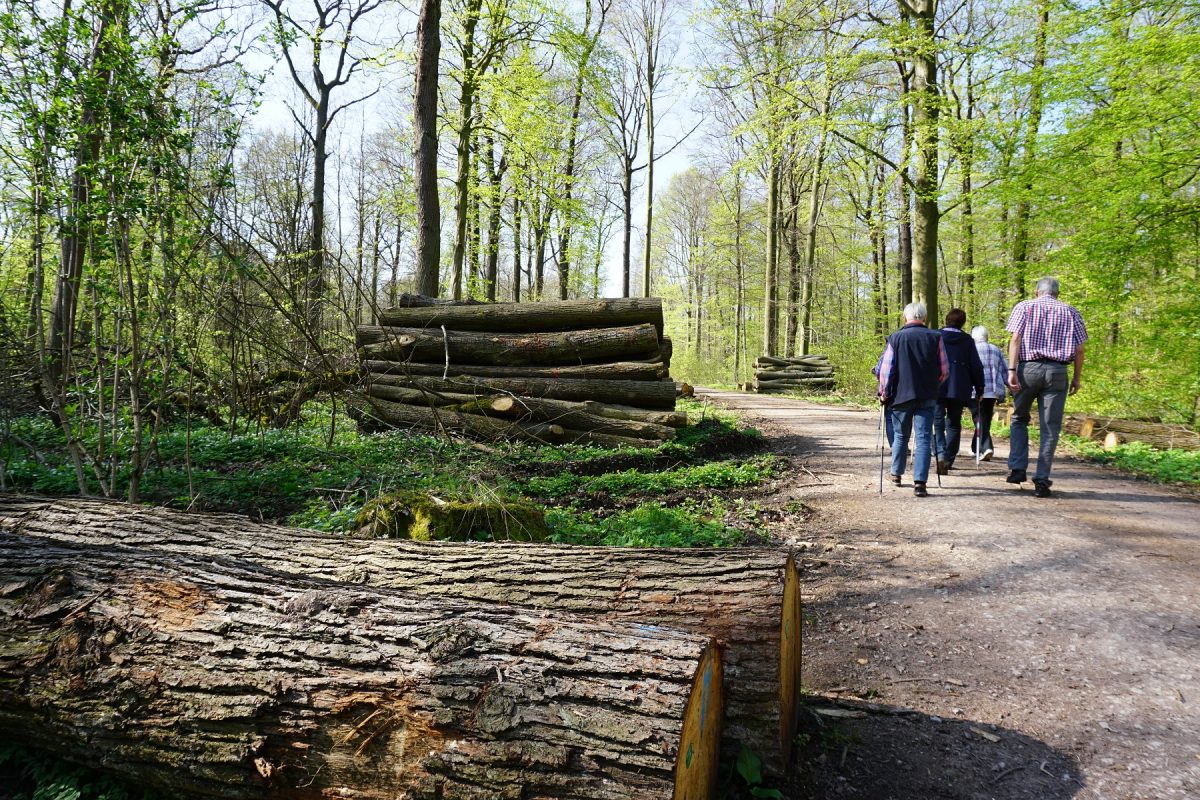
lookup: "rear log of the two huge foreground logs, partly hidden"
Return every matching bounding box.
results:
[0,494,803,774]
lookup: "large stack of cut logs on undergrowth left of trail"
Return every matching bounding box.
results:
[358,297,686,446]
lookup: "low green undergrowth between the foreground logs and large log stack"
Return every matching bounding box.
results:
[0,401,775,546]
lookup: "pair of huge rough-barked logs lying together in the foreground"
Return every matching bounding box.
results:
[0,493,802,800]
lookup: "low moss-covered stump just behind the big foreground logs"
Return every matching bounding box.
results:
[354,492,550,542]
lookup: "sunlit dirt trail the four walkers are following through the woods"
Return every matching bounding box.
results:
[697,391,1200,800]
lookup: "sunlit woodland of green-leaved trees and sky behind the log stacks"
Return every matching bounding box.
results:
[0,0,1200,499]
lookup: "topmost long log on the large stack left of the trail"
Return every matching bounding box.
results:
[379,297,662,336]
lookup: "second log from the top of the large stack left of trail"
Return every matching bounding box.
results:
[356,325,659,369]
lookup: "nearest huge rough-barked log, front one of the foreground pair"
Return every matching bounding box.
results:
[0,534,722,800]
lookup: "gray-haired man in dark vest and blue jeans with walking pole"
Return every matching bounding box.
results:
[880,302,948,498]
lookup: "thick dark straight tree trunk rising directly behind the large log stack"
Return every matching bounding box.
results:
[413,0,442,297]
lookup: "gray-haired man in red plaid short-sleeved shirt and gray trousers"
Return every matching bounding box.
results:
[1004,277,1087,498]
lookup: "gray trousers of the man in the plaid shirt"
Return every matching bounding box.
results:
[1008,361,1068,483]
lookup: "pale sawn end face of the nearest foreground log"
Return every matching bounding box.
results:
[672,644,725,800]
